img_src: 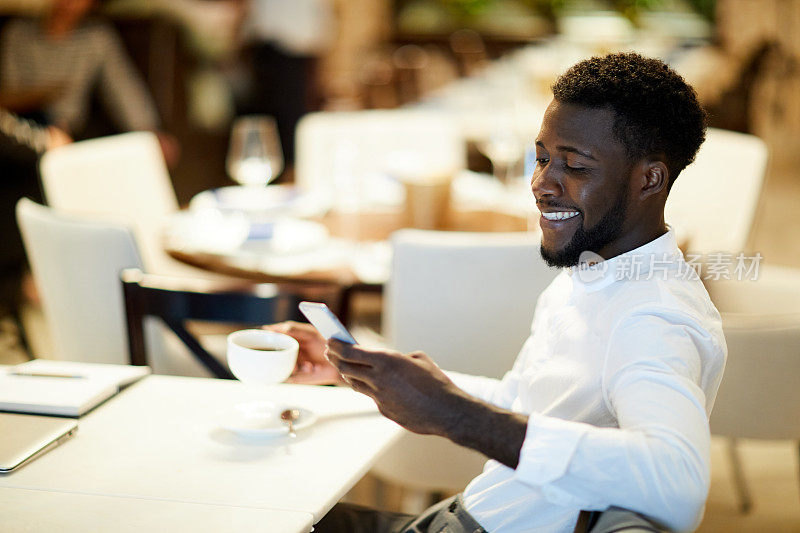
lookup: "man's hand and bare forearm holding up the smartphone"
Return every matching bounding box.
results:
[325,339,528,468]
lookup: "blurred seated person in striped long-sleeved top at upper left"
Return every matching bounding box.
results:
[0,0,178,165]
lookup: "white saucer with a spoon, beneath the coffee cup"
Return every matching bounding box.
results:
[220,401,317,438]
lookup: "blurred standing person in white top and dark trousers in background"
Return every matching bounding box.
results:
[242,0,335,165]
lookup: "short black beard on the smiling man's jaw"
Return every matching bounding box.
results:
[539,188,627,268]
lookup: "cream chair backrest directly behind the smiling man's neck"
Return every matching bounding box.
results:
[665,128,768,253]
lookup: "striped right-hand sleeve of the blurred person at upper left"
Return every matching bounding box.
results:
[98,26,159,131]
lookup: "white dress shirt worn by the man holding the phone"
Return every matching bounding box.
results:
[449,229,727,532]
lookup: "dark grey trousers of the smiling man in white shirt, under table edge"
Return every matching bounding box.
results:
[314,494,487,533]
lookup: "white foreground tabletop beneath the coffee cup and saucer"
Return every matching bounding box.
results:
[0,376,402,531]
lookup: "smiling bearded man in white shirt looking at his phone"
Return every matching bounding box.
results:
[268,54,726,532]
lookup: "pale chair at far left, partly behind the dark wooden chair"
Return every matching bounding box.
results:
[17,198,216,377]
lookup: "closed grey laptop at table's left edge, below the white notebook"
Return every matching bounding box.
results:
[0,413,78,474]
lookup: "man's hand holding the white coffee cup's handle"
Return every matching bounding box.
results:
[264,321,342,385]
